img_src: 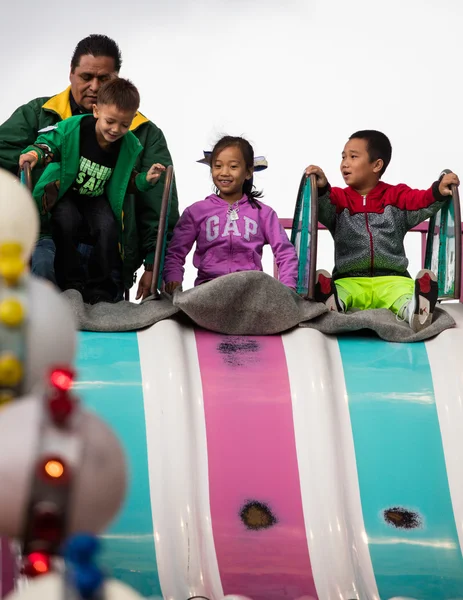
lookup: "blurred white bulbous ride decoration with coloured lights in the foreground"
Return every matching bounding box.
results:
[0,163,140,600]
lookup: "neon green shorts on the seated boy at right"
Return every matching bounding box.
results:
[335,276,415,314]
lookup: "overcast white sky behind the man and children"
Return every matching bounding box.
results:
[0,0,463,288]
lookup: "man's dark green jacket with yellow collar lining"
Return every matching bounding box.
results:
[0,87,179,287]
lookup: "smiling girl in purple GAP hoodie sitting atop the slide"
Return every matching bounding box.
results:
[164,136,298,294]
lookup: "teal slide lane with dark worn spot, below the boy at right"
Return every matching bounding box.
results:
[338,337,463,600]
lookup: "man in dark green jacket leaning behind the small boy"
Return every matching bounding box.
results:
[0,34,178,298]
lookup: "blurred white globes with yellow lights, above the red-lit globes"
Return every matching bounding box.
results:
[0,169,76,398]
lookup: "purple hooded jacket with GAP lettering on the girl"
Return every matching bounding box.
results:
[164,194,298,287]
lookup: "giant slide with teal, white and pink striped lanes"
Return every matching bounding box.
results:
[69,171,463,600]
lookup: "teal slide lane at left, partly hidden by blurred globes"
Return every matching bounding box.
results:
[75,332,161,596]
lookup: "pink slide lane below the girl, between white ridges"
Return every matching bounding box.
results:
[196,330,317,600]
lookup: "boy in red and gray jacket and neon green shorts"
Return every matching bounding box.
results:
[306,130,459,331]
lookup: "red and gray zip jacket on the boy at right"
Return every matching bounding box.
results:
[318,181,449,279]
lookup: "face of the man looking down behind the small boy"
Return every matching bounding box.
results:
[69,54,117,111]
